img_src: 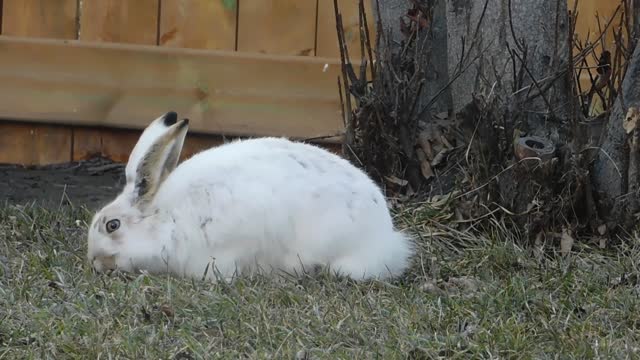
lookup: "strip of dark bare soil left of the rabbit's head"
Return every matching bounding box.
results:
[0,158,125,209]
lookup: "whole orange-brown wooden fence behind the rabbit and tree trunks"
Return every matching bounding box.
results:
[0,0,624,164]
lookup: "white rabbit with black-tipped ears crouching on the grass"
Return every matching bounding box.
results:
[87,112,414,281]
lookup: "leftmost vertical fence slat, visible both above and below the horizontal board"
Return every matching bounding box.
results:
[0,0,78,165]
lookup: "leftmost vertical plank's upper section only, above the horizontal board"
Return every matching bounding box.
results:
[2,0,78,39]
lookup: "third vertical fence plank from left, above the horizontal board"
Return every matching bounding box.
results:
[159,0,238,50]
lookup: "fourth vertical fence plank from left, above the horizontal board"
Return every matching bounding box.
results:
[238,0,316,56]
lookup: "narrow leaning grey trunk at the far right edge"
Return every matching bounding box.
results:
[592,46,640,222]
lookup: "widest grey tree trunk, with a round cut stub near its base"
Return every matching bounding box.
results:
[446,0,575,238]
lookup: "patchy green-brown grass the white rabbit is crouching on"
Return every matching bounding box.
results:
[0,200,640,359]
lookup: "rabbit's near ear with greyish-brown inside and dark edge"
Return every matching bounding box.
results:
[127,119,189,208]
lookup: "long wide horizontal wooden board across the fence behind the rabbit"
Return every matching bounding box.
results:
[0,36,343,141]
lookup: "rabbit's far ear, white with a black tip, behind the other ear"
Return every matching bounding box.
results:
[125,111,184,184]
